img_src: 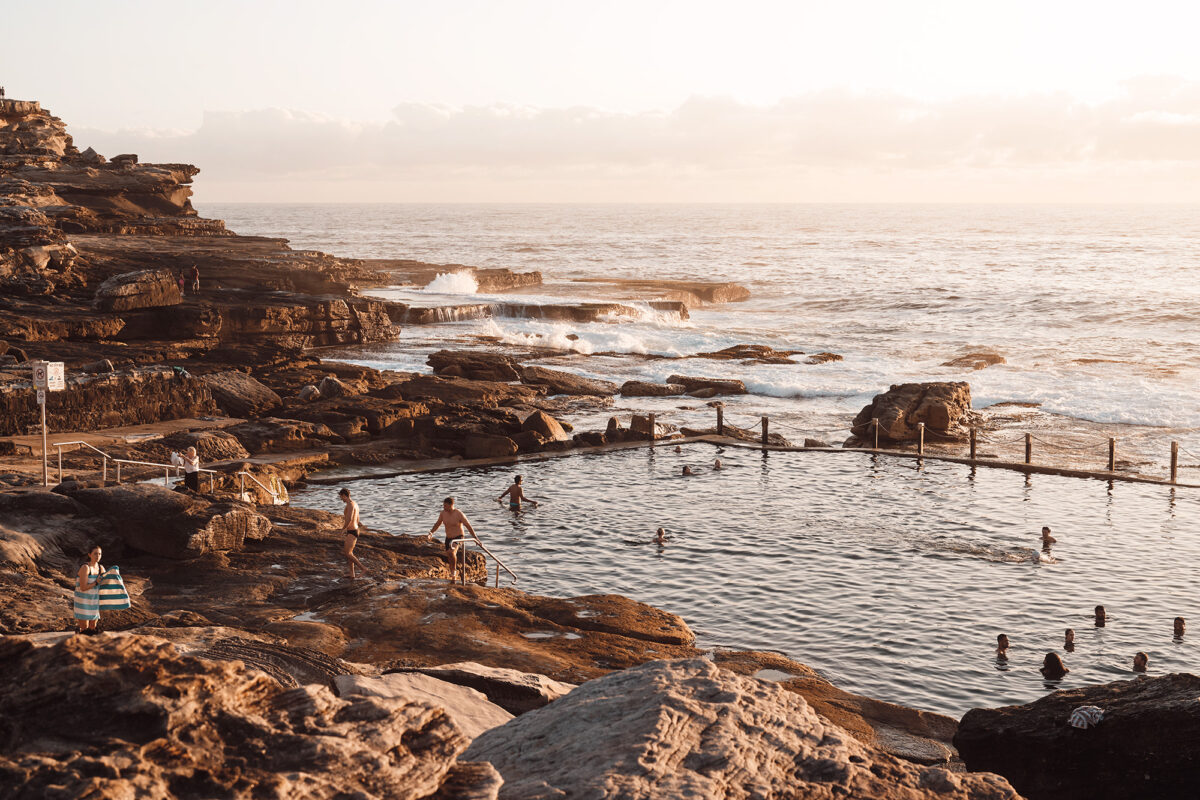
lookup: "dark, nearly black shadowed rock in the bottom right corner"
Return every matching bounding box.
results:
[954,673,1200,800]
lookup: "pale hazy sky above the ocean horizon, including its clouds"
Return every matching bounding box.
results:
[0,0,1200,203]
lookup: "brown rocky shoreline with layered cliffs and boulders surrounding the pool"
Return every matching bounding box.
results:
[0,101,1182,800]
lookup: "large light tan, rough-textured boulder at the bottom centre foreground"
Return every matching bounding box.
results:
[464,658,1018,800]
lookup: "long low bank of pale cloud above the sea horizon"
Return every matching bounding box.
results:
[76,78,1200,201]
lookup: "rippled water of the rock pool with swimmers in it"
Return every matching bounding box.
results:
[295,445,1200,716]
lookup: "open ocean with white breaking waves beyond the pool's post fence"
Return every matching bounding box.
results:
[199,204,1200,479]
